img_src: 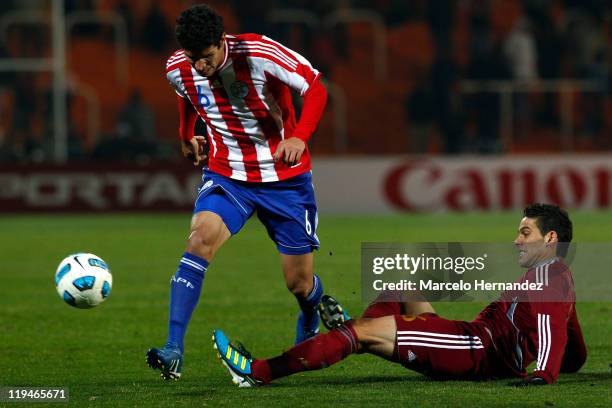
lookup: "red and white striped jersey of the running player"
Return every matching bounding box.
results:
[166,34,319,182]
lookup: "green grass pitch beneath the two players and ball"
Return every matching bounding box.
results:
[0,212,612,407]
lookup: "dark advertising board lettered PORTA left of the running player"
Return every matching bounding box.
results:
[0,165,202,212]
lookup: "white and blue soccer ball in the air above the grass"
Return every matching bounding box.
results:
[55,253,113,309]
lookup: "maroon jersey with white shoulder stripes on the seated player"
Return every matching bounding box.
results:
[475,258,586,383]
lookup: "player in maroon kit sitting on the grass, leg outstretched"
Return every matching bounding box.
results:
[213,204,587,387]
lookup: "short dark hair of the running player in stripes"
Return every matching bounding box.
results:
[176,4,224,52]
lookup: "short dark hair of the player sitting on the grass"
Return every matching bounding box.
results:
[523,203,573,257]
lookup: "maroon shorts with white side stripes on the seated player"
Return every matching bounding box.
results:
[395,313,496,380]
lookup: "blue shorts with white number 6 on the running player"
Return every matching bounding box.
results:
[193,170,319,255]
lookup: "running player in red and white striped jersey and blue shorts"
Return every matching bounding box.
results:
[146,5,327,379]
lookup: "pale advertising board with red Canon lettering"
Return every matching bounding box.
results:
[313,155,612,214]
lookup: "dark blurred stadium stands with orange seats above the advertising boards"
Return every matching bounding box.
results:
[0,0,612,163]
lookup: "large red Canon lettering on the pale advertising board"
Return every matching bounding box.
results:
[384,158,612,211]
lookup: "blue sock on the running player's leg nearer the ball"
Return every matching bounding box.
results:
[167,252,208,352]
